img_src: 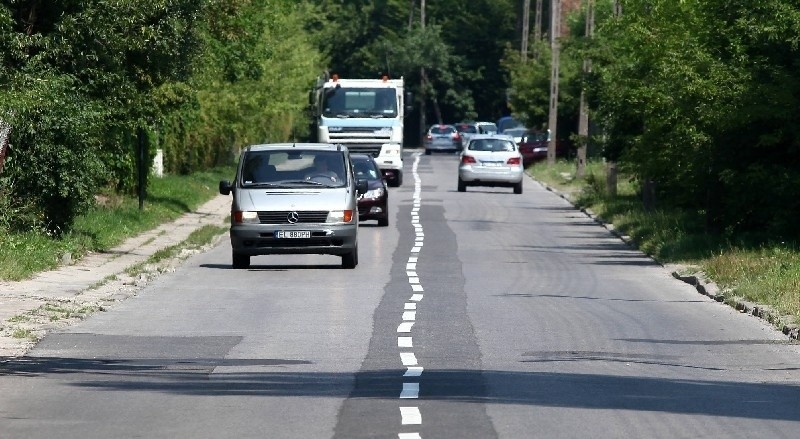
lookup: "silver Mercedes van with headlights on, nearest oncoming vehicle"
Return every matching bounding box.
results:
[219,143,367,268]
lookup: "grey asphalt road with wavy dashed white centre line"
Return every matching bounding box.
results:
[0,150,800,439]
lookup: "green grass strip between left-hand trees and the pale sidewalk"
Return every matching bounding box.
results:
[0,167,235,280]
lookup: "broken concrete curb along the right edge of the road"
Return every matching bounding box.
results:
[531,176,800,340]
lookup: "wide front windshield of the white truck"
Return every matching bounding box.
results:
[322,87,397,117]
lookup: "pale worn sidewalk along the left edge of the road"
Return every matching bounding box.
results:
[0,195,231,361]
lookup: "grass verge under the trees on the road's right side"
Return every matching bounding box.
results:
[528,161,800,323]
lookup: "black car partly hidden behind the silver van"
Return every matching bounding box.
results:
[350,154,389,227]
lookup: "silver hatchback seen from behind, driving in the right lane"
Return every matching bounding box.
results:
[458,134,524,194]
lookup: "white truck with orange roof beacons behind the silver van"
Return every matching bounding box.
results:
[309,75,412,187]
